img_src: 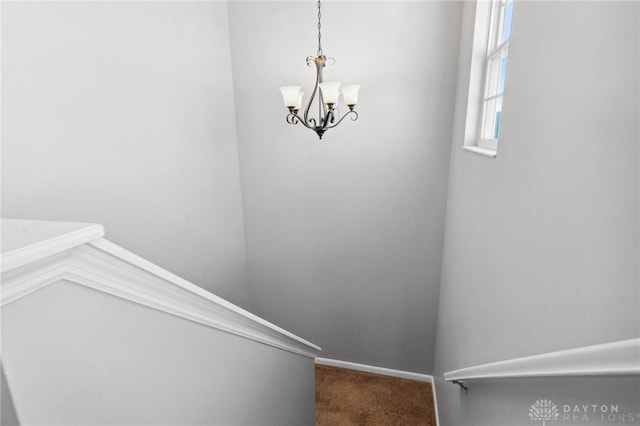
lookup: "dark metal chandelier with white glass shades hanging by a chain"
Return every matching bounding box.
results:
[280,0,360,139]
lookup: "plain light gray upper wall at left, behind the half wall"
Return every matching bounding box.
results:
[2,2,247,306]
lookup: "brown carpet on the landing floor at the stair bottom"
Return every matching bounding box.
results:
[316,365,436,426]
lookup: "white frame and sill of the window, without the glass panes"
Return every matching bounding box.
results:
[463,0,514,157]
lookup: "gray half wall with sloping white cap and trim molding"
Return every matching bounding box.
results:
[0,219,320,426]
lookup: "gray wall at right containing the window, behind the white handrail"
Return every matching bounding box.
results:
[435,1,640,426]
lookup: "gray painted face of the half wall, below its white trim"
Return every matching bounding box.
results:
[2,281,315,426]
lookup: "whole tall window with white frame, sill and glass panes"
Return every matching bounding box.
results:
[464,0,514,157]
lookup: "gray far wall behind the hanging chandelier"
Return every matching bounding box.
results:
[229,2,462,372]
